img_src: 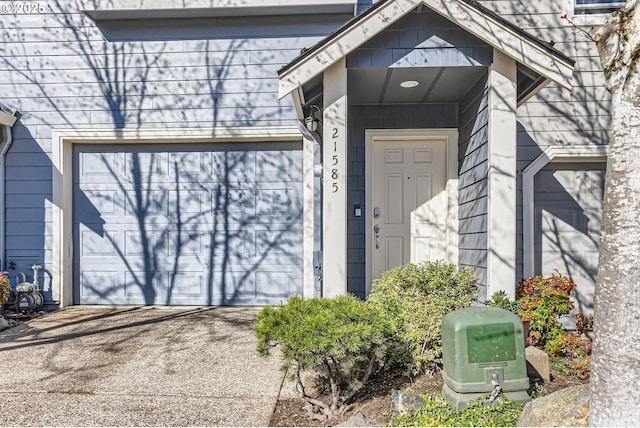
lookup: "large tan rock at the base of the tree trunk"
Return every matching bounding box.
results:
[518,383,589,427]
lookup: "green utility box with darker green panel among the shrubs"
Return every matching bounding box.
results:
[442,306,530,408]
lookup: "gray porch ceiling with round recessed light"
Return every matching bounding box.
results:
[348,67,486,104]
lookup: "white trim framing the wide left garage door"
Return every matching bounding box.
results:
[51,126,314,307]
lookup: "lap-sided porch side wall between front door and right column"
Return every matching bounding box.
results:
[458,75,489,295]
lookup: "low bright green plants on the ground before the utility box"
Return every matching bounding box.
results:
[389,395,523,427]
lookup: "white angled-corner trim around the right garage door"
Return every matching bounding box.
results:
[522,146,609,278]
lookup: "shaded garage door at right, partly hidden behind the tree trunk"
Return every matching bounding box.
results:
[535,162,605,313]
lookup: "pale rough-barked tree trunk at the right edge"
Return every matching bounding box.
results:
[590,0,640,426]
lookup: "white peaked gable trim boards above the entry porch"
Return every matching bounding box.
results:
[278,0,575,98]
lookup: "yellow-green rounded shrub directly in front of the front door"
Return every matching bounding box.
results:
[368,262,477,373]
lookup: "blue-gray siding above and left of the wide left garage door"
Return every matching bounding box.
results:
[0,0,349,301]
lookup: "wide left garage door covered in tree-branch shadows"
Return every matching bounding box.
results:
[73,142,302,305]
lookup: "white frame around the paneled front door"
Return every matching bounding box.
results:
[365,128,458,295]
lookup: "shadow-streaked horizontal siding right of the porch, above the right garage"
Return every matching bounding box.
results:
[481,0,611,284]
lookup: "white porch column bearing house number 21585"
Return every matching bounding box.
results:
[322,58,347,297]
